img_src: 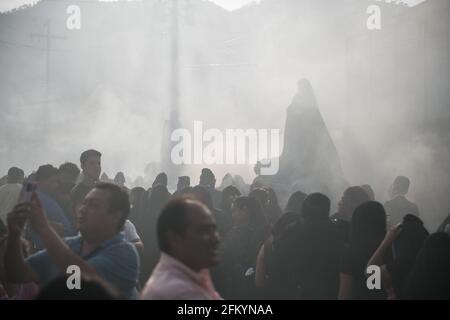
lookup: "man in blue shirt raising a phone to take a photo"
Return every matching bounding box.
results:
[5,183,139,299]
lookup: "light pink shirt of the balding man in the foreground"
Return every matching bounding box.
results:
[141,253,222,300]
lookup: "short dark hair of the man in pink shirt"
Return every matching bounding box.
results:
[156,198,209,253]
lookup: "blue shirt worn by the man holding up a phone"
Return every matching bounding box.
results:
[26,233,139,299]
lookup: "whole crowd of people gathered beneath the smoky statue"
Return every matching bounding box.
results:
[0,150,450,300]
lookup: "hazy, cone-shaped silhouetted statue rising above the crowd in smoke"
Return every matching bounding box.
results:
[256,79,346,205]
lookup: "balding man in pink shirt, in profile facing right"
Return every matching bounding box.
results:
[141,199,222,300]
